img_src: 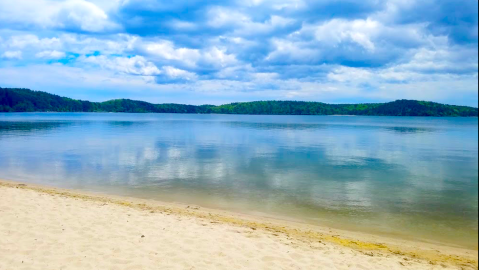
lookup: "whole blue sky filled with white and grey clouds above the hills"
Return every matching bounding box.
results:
[0,0,478,107]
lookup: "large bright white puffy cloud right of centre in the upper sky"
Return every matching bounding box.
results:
[266,18,434,66]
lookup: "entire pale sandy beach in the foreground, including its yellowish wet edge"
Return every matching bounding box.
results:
[0,181,477,270]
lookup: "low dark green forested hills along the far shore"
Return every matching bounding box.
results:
[0,88,478,117]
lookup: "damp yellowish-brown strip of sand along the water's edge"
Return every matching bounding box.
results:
[0,180,478,269]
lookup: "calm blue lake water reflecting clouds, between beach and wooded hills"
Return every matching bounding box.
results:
[0,113,478,248]
